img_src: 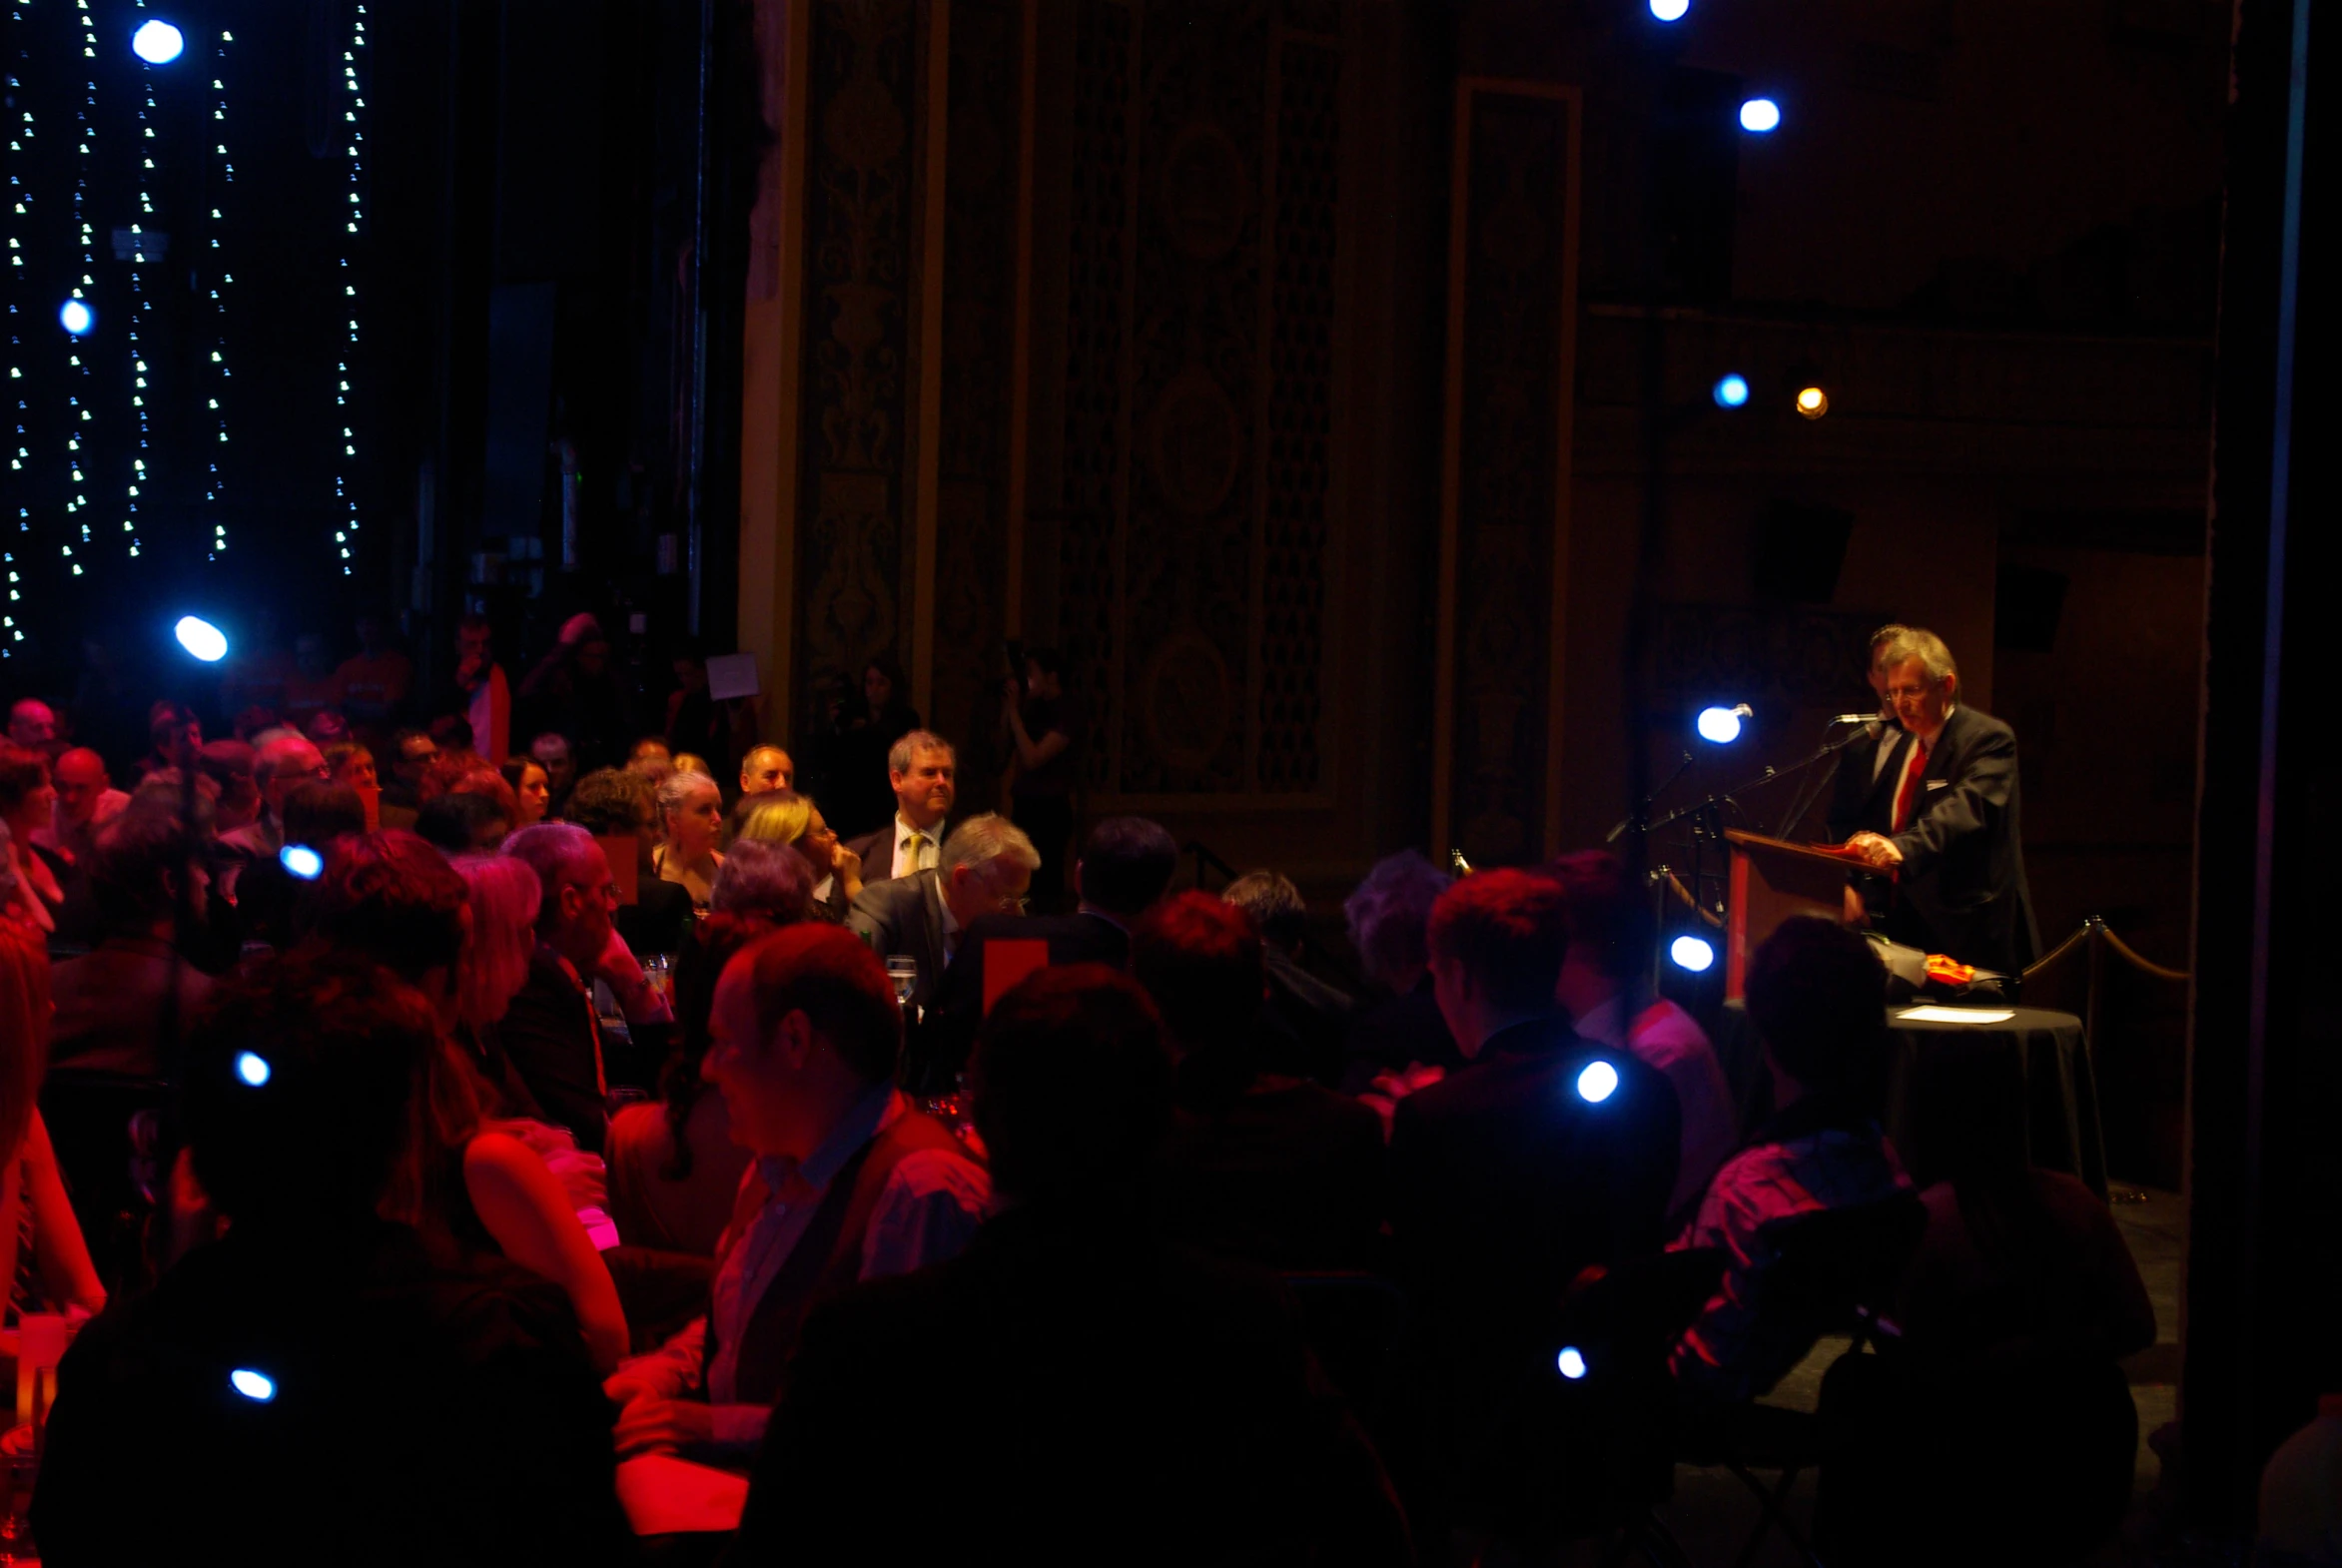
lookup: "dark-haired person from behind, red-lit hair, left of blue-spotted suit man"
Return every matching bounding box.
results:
[1132,892,1384,1268]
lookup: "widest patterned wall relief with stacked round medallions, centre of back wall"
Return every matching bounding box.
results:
[1059,0,1342,796]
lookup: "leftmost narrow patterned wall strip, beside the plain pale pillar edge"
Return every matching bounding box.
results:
[796,0,918,711]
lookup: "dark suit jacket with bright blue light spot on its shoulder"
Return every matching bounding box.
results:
[1391,1018,1682,1516]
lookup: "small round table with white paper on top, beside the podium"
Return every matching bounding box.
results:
[1715,1002,2105,1198]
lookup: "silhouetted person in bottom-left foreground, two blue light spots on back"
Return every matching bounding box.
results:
[33,957,632,1563]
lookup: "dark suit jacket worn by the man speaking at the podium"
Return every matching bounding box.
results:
[1888,704,2042,974]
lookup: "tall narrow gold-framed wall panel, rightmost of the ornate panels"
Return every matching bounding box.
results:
[1433,80,1576,864]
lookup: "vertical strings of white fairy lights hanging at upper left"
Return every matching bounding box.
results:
[0,0,373,657]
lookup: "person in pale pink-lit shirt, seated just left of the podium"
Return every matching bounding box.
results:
[1550,850,1740,1221]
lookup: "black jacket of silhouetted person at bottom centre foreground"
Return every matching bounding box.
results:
[724,1207,1400,1568]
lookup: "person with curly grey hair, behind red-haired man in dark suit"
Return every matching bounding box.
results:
[1342,850,1464,1105]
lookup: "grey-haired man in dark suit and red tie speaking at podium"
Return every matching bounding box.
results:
[1846,629,2039,974]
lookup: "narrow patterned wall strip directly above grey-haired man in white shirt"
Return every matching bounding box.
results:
[928,0,1024,812]
